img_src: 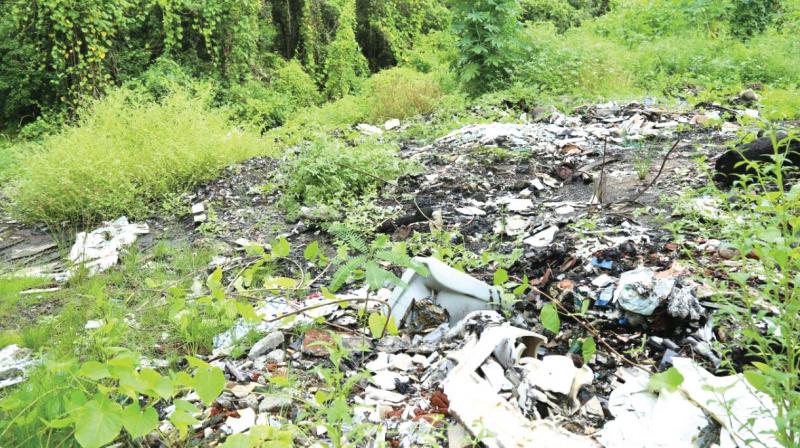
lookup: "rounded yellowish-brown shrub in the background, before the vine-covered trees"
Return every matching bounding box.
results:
[366,68,442,120]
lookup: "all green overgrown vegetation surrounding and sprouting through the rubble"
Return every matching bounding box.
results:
[0,0,800,447]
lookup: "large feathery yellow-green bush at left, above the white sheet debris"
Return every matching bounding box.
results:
[6,89,266,223]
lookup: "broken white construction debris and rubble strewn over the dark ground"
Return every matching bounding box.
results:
[0,103,778,448]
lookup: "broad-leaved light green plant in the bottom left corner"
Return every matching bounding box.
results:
[0,350,225,448]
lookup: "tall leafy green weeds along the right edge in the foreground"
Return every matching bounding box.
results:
[672,132,800,447]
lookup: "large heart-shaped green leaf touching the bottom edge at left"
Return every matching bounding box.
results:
[75,397,122,448]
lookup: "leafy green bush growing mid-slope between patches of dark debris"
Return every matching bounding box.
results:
[283,139,411,212]
